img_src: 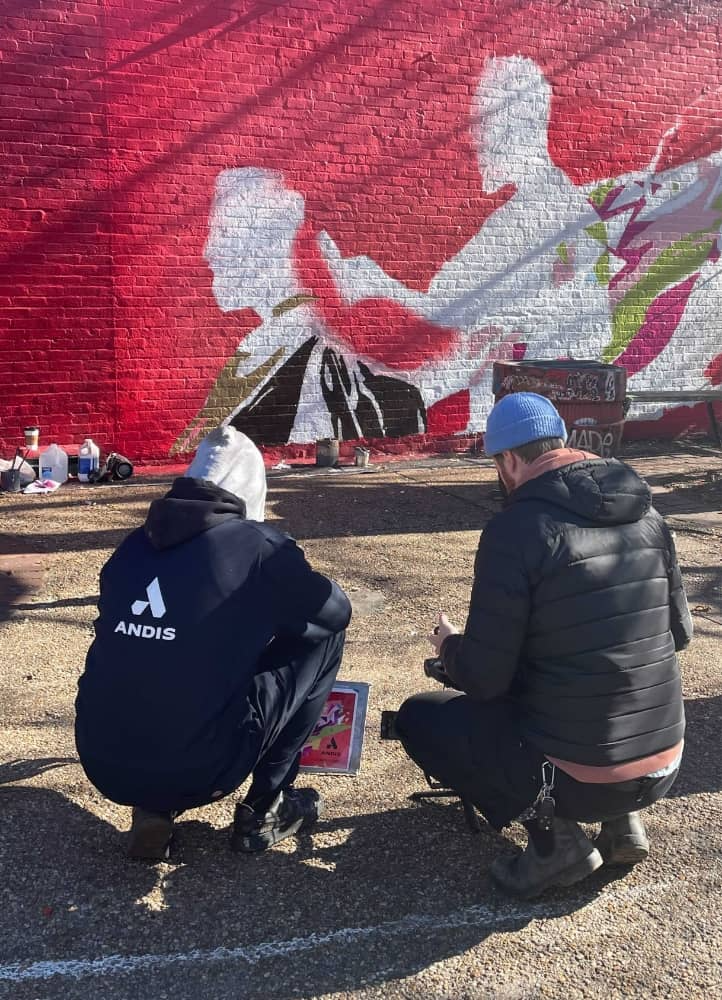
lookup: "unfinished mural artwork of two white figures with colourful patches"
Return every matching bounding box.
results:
[171,50,722,454]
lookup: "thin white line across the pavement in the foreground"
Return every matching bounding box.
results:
[0,882,676,983]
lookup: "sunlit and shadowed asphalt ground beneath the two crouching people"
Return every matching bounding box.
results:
[0,446,722,1000]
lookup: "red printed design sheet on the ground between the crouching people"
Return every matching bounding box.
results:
[300,681,369,774]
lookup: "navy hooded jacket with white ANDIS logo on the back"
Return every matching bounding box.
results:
[75,478,351,804]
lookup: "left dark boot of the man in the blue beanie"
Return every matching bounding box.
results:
[491,817,604,899]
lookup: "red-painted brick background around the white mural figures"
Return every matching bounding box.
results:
[0,0,722,458]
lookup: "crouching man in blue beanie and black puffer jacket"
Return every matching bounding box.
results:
[396,393,692,898]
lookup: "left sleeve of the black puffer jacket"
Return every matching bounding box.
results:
[441,515,531,701]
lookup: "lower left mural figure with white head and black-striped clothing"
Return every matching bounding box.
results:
[173,167,426,453]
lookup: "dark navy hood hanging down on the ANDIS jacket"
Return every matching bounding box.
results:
[144,476,246,550]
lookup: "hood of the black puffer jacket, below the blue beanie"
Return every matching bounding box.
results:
[507,458,652,525]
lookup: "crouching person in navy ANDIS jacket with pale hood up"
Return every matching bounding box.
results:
[75,427,351,859]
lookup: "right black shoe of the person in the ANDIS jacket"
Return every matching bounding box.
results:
[231,788,324,854]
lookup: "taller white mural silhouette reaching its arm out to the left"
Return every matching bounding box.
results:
[320,56,611,430]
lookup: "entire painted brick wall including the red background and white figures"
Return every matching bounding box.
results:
[0,0,722,459]
